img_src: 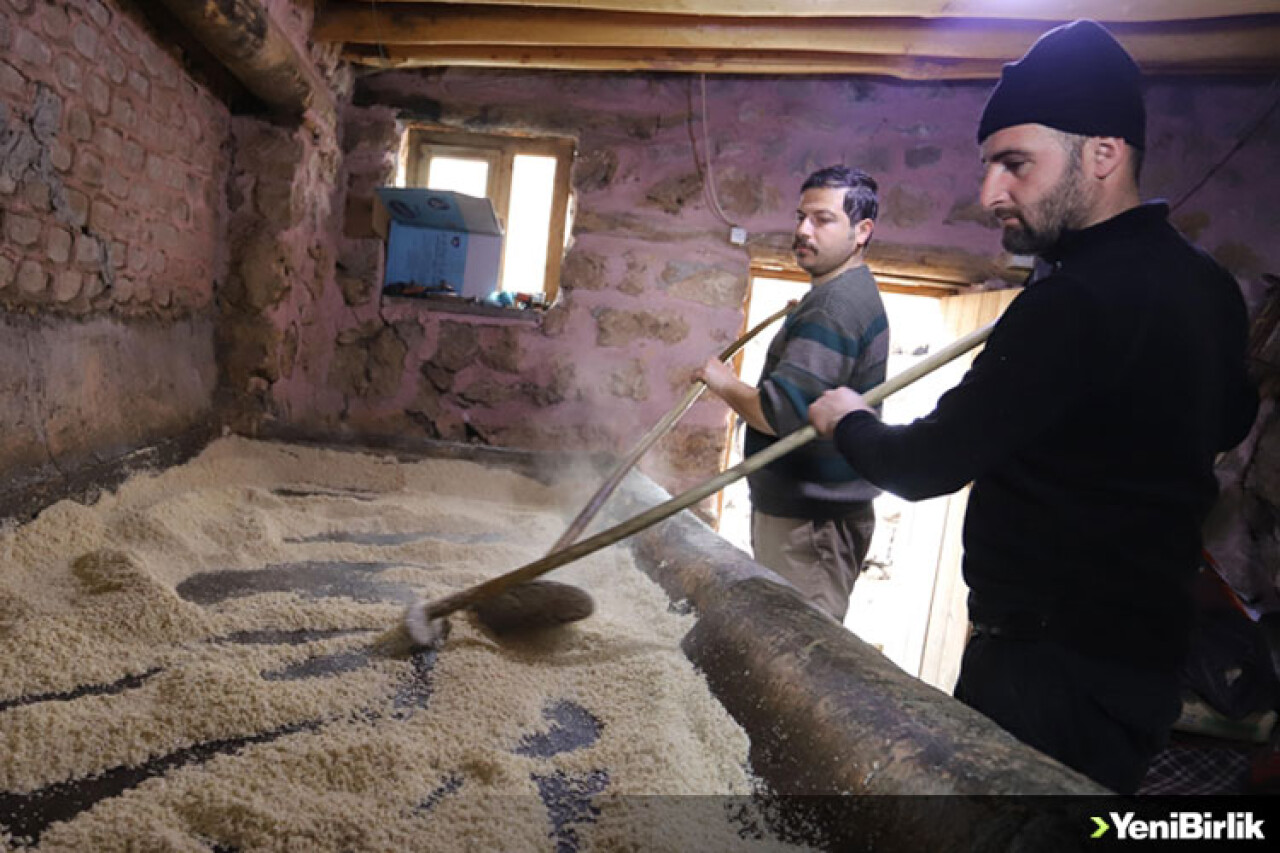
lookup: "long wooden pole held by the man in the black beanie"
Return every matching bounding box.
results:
[404,323,995,646]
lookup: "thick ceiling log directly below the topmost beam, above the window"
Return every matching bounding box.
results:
[312,3,1280,68]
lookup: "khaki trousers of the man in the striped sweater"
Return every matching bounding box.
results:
[751,501,876,624]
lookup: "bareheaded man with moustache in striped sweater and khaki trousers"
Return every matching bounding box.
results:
[699,165,888,621]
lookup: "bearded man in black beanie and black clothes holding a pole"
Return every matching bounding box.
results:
[809,20,1257,793]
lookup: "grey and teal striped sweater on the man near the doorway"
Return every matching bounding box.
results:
[745,266,888,519]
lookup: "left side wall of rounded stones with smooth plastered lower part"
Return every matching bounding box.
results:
[0,0,229,502]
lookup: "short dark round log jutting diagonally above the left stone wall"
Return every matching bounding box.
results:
[152,0,337,122]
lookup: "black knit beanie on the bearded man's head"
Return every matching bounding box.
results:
[978,20,1147,149]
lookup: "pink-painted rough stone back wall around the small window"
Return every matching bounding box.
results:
[309,70,1280,502]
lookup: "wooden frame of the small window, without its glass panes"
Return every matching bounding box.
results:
[404,124,577,305]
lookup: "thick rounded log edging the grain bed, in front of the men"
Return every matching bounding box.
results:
[614,474,1102,799]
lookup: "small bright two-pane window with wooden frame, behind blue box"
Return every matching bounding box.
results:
[403,127,573,305]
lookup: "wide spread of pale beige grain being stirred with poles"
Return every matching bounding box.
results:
[0,438,803,850]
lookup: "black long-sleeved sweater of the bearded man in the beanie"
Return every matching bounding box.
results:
[835,204,1257,666]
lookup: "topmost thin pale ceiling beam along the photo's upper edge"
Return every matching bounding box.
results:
[358,0,1280,23]
